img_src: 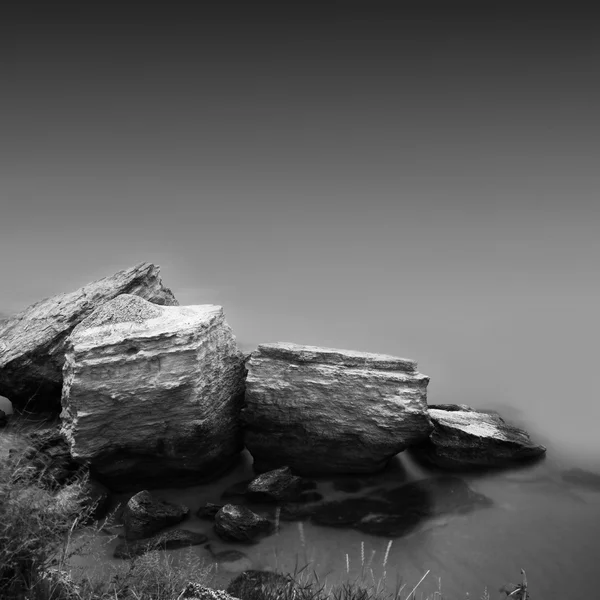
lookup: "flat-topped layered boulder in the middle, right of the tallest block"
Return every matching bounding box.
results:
[241,343,432,475]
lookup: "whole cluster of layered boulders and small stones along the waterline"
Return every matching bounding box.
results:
[0,263,546,580]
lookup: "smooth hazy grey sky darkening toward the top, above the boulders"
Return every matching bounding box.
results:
[0,1,600,454]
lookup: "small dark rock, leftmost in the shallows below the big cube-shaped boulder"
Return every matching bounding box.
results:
[123,490,189,540]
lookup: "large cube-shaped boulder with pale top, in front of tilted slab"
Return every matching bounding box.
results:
[61,294,245,491]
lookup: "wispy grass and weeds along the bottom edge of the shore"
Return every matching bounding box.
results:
[0,418,528,600]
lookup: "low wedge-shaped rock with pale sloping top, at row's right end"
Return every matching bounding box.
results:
[411,408,546,470]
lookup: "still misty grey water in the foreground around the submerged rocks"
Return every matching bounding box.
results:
[57,436,600,599]
